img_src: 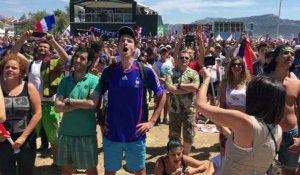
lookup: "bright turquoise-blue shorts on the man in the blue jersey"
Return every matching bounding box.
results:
[103,136,146,172]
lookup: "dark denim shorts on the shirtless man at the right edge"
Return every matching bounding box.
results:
[278,128,299,169]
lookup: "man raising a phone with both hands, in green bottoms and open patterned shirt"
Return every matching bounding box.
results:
[11,30,68,167]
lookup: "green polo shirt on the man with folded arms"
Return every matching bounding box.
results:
[57,73,100,136]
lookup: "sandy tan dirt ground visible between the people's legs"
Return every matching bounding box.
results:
[35,104,218,175]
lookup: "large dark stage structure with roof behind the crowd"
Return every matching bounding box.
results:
[69,0,163,36]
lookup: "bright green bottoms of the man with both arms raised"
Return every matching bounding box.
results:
[36,101,59,144]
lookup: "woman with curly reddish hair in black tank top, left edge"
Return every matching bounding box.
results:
[0,54,41,175]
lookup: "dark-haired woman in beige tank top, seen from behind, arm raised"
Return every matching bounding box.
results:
[196,68,286,175]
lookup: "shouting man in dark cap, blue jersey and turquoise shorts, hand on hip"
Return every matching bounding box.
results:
[101,26,166,175]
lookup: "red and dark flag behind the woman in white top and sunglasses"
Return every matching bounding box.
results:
[237,41,253,75]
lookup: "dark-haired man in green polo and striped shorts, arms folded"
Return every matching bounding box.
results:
[55,50,99,175]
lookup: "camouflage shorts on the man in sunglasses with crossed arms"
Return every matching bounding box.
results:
[169,112,195,143]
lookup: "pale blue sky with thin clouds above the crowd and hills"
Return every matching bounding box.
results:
[0,0,300,24]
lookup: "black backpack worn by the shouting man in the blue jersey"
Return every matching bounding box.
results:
[97,62,149,126]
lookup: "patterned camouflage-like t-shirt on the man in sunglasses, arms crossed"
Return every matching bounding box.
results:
[166,67,200,114]
